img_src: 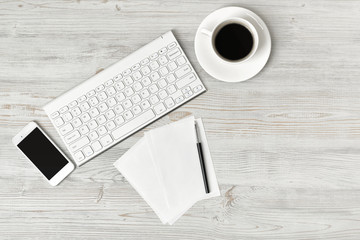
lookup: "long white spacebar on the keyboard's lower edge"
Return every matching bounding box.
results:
[112,110,155,139]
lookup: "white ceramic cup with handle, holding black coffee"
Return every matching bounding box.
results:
[200,18,259,64]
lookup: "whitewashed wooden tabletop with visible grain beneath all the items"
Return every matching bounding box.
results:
[0,0,360,239]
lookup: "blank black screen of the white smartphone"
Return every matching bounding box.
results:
[18,128,68,180]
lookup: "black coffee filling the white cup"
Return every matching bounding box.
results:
[214,23,254,61]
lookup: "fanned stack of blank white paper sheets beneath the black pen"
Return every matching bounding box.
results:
[114,116,220,224]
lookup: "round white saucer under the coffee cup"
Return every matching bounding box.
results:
[195,7,271,82]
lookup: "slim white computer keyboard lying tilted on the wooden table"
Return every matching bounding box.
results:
[44,31,206,166]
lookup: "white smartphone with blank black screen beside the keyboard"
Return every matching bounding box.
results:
[12,122,75,186]
